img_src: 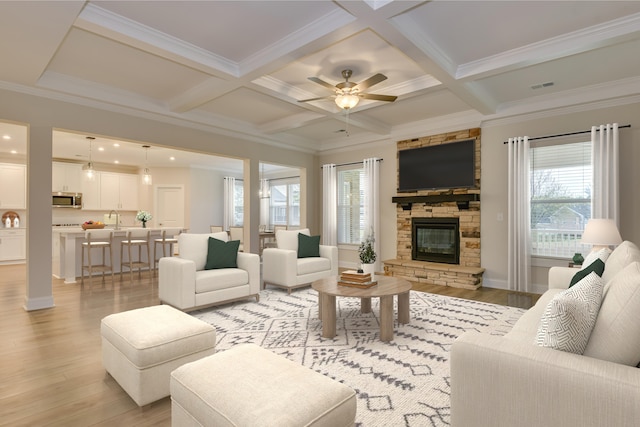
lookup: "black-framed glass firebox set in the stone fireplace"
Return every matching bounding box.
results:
[411,218,460,264]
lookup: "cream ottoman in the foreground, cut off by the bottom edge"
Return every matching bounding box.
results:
[171,344,356,427]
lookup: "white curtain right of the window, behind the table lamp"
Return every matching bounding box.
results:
[591,123,620,228]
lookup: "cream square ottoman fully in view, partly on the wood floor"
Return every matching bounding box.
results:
[100,305,216,406]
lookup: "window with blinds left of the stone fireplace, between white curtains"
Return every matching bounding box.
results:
[337,167,364,245]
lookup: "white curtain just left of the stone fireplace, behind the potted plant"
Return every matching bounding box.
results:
[363,157,380,271]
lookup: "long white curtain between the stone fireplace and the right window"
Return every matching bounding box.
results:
[507,136,531,292]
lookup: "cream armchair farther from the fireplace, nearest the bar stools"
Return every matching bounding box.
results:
[158,232,260,311]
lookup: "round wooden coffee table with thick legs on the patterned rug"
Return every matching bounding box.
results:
[311,275,411,342]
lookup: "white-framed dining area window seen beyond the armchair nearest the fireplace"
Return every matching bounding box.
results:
[269,177,300,228]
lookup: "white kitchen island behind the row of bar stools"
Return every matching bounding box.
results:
[52,227,184,283]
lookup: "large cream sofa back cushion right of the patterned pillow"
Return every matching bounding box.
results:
[584,262,640,366]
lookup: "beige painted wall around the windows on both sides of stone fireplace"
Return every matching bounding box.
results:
[316,104,640,292]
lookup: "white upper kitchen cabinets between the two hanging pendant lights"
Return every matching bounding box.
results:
[100,172,138,211]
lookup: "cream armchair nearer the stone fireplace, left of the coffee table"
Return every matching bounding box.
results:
[262,228,338,293]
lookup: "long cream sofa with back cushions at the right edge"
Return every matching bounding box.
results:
[451,241,640,427]
